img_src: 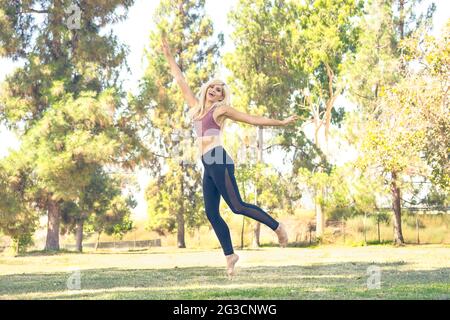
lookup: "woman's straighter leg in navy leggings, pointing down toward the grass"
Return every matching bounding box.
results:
[203,167,234,255]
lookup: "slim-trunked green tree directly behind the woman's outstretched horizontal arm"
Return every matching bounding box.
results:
[224,0,302,246]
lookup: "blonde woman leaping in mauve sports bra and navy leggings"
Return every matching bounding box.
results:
[162,37,297,277]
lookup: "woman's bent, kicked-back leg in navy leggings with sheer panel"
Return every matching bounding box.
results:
[210,159,279,231]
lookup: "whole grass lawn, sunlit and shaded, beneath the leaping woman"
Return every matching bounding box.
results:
[0,245,450,300]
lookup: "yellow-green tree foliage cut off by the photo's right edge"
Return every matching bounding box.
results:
[402,20,450,193]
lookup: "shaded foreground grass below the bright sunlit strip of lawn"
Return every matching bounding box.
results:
[0,261,450,300]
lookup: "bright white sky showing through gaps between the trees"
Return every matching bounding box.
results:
[0,0,450,219]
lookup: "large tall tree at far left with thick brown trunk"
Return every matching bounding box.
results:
[0,0,144,250]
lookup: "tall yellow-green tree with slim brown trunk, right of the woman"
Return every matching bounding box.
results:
[342,0,435,244]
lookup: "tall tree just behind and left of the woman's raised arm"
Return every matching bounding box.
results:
[137,0,223,248]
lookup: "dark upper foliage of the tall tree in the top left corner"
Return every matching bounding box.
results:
[0,0,133,129]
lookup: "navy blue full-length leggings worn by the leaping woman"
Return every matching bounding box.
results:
[202,146,278,255]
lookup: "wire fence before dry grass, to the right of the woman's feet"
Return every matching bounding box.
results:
[289,208,450,246]
